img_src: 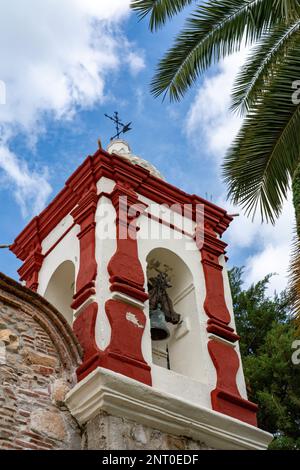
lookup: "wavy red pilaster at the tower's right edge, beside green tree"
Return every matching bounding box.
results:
[195,220,258,426]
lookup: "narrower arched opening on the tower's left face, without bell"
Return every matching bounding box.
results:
[44,261,75,325]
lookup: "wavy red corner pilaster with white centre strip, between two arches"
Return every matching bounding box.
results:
[72,184,151,385]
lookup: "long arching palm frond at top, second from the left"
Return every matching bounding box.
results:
[151,0,290,100]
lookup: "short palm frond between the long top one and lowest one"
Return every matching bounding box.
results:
[231,19,300,114]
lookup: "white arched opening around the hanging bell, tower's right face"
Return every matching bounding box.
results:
[147,248,200,378]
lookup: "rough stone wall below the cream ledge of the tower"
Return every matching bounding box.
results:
[82,412,209,450]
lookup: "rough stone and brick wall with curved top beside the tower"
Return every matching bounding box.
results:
[0,274,81,449]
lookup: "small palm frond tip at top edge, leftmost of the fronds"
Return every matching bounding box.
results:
[130,0,195,31]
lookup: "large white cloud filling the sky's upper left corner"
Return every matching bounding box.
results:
[0,0,145,217]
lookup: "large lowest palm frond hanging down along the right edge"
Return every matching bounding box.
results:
[223,35,300,223]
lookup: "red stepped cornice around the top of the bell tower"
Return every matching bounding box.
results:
[11,150,232,261]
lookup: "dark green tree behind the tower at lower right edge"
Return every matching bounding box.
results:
[229,268,300,450]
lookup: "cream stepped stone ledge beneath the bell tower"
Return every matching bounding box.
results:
[66,368,273,450]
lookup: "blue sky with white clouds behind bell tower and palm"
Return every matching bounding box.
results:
[0,0,293,293]
